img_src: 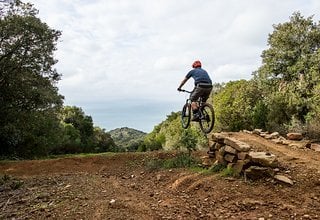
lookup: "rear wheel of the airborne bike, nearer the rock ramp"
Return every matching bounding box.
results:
[199,103,214,134]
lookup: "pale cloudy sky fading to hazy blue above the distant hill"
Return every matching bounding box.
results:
[24,0,320,132]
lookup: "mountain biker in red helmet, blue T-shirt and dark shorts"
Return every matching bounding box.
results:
[178,60,212,121]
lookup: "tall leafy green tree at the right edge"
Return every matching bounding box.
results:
[256,12,320,124]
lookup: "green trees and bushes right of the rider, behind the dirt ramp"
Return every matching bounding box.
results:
[213,12,320,138]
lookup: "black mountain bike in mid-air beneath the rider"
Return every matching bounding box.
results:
[180,89,215,134]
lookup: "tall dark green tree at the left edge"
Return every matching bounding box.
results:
[0,0,63,156]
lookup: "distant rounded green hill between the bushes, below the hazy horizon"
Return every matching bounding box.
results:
[108,127,147,151]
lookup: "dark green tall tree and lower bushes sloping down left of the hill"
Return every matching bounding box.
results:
[0,0,118,158]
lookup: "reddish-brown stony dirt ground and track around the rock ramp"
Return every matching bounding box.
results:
[0,133,320,220]
